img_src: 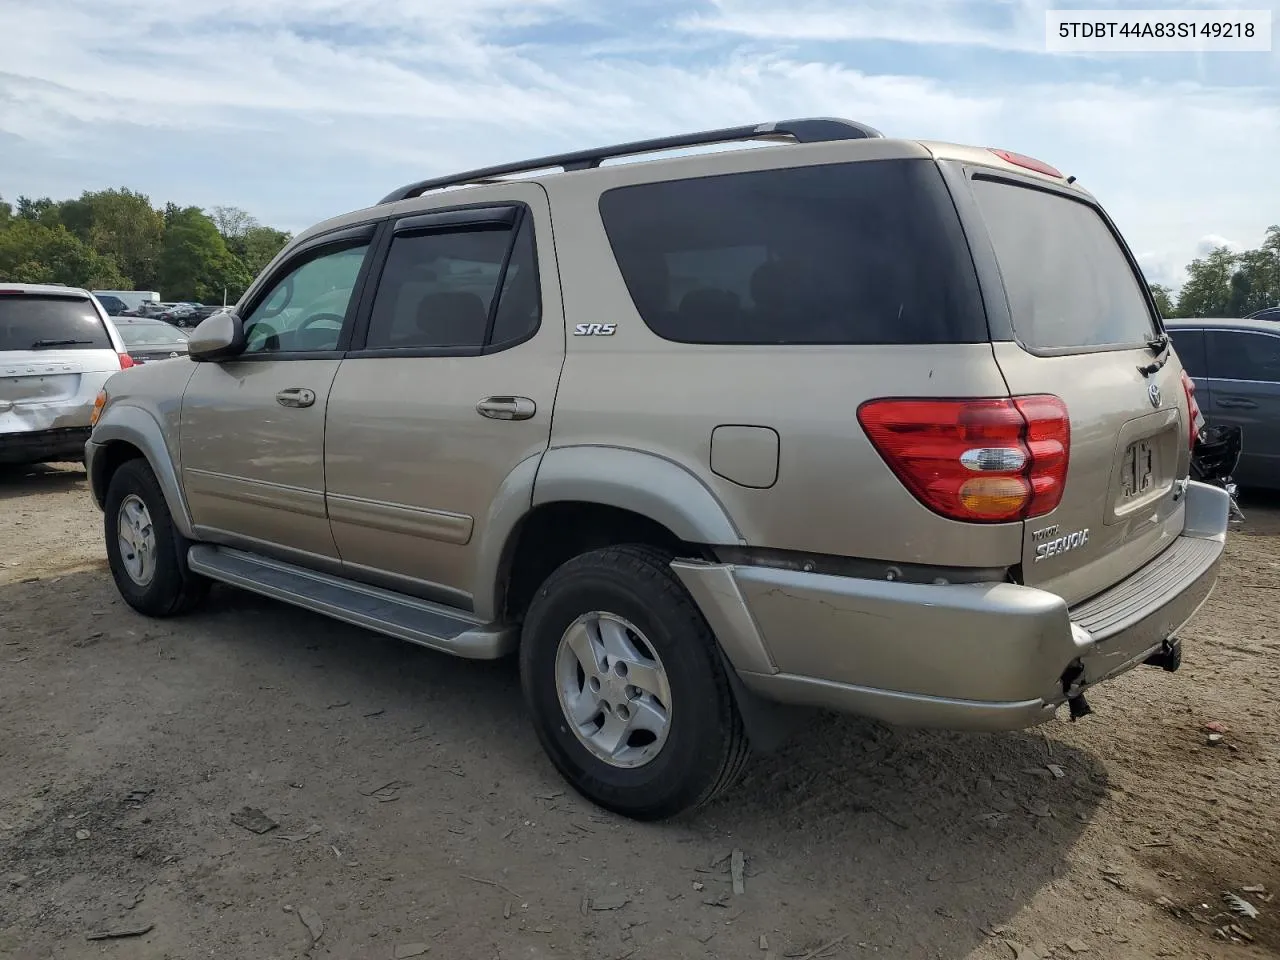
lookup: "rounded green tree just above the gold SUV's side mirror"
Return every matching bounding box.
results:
[159,205,248,303]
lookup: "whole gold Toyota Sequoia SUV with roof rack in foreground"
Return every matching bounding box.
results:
[86,120,1228,818]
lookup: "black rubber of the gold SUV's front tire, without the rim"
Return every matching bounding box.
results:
[102,460,209,617]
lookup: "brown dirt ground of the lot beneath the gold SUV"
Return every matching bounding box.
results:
[0,467,1280,960]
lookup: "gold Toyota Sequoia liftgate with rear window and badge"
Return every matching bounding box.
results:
[970,172,1190,603]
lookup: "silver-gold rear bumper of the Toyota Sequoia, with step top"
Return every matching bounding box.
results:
[672,484,1228,730]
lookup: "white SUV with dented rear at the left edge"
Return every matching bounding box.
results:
[0,283,133,463]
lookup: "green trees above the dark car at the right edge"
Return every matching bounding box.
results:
[1151,227,1280,317]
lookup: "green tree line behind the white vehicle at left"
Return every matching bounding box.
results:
[0,187,289,303]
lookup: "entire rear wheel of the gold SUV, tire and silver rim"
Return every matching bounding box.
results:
[520,545,749,820]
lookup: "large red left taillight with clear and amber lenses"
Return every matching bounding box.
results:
[858,396,1071,524]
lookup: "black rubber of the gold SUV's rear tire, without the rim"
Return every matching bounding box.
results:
[520,545,750,820]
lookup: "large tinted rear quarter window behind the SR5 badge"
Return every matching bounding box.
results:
[600,160,987,344]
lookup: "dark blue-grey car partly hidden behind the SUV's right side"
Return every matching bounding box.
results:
[1165,317,1280,490]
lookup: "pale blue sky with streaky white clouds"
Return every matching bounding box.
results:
[0,0,1280,284]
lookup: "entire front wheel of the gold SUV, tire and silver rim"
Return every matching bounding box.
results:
[102,460,209,617]
